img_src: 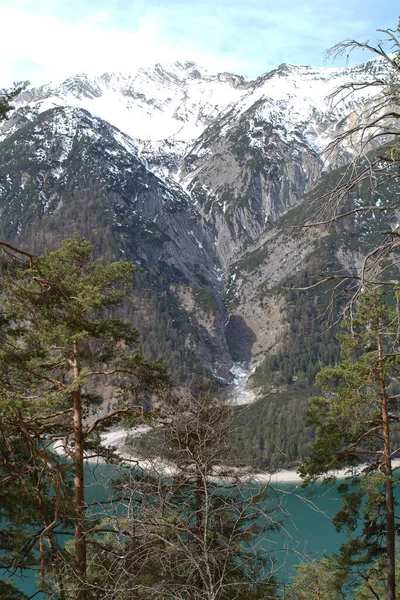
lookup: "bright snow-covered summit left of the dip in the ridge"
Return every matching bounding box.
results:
[7,62,246,143]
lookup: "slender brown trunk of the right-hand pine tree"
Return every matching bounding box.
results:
[378,335,396,600]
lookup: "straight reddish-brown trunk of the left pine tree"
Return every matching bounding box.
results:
[73,341,86,600]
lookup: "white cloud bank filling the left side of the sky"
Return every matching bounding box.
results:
[0,7,253,86]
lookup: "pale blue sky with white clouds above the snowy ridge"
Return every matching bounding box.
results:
[0,0,400,87]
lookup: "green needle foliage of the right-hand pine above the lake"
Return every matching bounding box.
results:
[300,292,399,475]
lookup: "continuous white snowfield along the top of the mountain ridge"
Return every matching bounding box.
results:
[16,59,385,158]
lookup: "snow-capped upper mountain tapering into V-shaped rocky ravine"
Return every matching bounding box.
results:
[3,60,387,267]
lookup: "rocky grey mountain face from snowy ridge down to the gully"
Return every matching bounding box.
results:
[0,61,390,390]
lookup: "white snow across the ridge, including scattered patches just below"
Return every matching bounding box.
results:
[0,59,386,203]
